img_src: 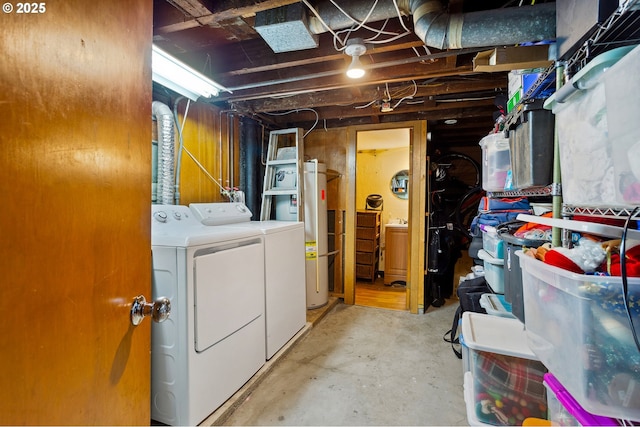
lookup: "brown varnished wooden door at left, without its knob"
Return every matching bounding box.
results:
[0,0,152,425]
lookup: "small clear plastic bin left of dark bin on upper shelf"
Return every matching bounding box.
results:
[480,132,511,191]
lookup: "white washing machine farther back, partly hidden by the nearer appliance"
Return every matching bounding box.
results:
[189,203,307,359]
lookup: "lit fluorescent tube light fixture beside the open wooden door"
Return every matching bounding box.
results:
[151,45,231,101]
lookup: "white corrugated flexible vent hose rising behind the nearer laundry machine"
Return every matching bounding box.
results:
[151,101,175,205]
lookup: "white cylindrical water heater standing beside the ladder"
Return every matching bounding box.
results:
[276,160,329,309]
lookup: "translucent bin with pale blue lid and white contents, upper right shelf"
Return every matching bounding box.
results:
[544,46,637,208]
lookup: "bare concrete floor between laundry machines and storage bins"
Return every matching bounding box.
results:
[203,298,468,426]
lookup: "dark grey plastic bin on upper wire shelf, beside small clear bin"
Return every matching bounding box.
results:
[509,99,555,190]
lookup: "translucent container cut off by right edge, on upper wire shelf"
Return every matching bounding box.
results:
[604,47,640,206]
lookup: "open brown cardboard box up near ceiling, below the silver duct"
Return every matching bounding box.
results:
[473,45,553,73]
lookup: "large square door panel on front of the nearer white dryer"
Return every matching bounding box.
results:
[194,238,265,352]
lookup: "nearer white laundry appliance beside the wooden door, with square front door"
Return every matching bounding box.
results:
[151,205,265,425]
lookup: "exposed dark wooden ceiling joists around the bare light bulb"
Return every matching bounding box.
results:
[154,0,552,149]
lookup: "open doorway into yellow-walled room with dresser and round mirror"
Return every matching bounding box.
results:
[355,128,411,310]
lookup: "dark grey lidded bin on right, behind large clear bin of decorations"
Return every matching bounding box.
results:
[498,230,547,323]
